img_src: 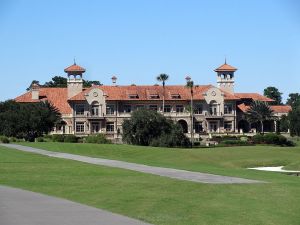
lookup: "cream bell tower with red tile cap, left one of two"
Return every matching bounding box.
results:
[64,60,85,99]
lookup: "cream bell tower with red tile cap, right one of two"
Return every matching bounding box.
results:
[215,59,237,93]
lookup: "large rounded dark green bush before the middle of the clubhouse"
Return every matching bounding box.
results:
[123,109,189,146]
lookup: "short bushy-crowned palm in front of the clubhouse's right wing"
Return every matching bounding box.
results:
[246,101,274,133]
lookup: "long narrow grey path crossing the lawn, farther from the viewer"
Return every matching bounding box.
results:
[1,144,265,184]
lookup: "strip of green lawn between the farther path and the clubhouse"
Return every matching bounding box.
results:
[19,142,300,178]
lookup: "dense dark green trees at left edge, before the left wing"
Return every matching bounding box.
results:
[0,101,61,141]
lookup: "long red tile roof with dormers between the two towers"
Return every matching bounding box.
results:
[69,85,239,101]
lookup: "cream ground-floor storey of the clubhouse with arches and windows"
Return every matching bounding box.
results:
[52,115,279,139]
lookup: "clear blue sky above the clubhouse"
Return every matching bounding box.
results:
[0,0,300,101]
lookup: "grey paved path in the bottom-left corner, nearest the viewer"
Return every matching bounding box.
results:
[0,186,150,225]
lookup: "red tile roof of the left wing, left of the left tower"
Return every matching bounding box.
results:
[15,87,72,114]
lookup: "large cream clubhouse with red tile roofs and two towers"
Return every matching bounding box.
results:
[15,62,291,139]
